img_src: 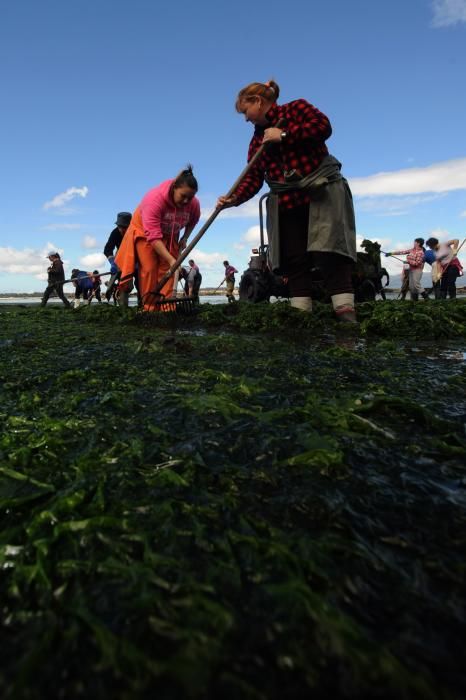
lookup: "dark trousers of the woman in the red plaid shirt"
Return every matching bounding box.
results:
[280,205,354,297]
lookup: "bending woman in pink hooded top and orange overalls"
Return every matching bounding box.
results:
[115,165,201,311]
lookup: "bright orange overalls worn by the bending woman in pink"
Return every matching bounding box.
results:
[115,207,179,311]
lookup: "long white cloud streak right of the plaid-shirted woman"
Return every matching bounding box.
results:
[350,158,466,197]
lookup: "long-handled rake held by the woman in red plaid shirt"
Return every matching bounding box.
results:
[141,119,284,314]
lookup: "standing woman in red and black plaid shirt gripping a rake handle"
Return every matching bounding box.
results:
[217,80,356,322]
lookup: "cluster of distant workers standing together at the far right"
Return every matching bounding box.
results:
[385,237,463,301]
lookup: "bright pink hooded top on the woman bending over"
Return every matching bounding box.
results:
[140,179,201,249]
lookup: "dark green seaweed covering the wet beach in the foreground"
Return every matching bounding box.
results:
[0,300,466,700]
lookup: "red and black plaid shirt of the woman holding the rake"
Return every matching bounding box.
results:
[235,100,332,209]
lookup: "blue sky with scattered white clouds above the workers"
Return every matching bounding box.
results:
[0,0,466,292]
